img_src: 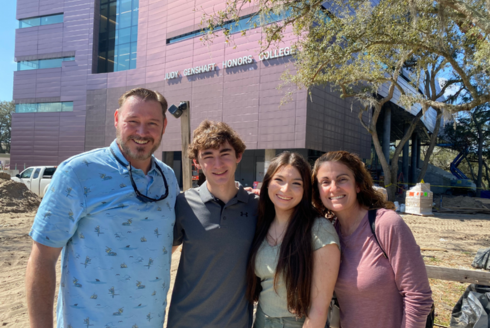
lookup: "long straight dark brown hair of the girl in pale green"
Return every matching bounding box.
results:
[246,152,319,317]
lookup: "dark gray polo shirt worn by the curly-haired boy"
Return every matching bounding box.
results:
[167,182,258,328]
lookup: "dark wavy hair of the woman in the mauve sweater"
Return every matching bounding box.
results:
[312,150,392,217]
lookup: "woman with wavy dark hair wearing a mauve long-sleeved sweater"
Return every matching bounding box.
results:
[313,151,432,328]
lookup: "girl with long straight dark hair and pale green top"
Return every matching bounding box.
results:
[247,152,340,328]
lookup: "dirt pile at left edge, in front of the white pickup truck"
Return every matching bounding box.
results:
[0,176,41,213]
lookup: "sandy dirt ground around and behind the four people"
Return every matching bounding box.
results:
[0,205,490,328]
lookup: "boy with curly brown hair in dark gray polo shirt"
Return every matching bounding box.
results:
[167,120,258,328]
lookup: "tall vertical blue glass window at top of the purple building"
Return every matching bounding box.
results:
[97,0,139,73]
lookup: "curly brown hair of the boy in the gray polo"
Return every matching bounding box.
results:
[189,120,247,160]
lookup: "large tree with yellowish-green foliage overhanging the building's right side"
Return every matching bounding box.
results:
[203,0,490,199]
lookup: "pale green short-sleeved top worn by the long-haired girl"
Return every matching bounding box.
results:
[255,218,340,318]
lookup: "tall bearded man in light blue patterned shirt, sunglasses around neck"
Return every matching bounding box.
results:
[26,88,179,328]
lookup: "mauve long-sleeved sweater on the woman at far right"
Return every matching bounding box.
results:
[335,209,432,328]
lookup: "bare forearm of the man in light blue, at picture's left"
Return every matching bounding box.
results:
[26,241,61,328]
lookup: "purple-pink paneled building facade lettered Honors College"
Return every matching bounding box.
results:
[11,0,371,185]
